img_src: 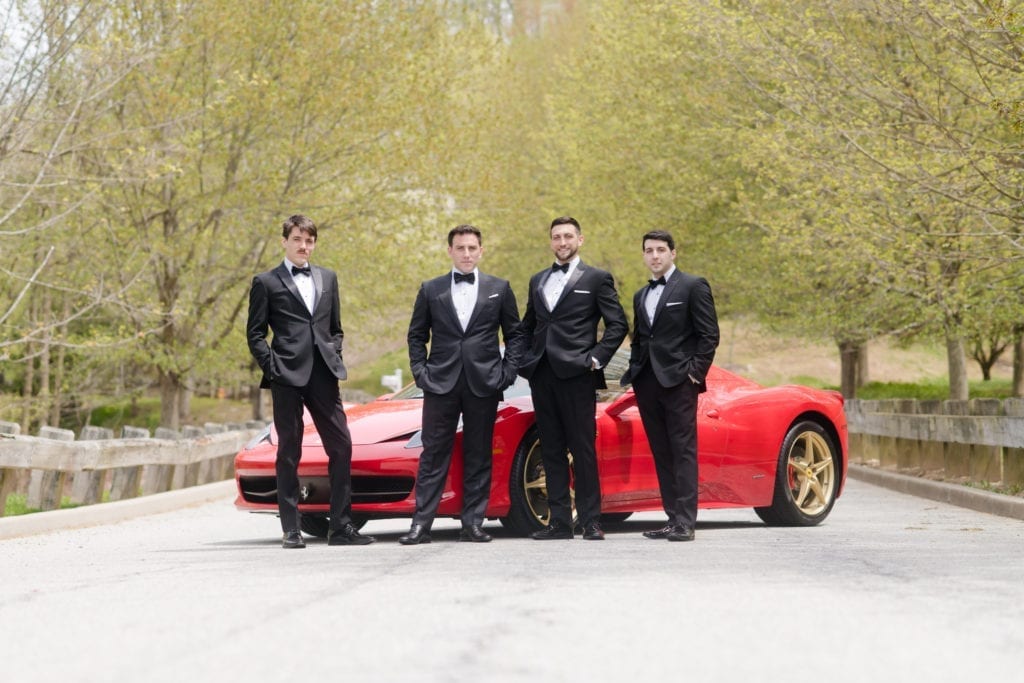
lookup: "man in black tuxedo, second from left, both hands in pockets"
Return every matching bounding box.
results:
[398,225,521,546]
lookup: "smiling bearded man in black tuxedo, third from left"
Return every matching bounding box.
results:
[519,216,629,541]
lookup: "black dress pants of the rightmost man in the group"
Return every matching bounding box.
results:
[633,364,699,528]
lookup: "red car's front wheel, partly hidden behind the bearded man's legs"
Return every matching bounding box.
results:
[501,426,577,536]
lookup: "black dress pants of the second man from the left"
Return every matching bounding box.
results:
[413,373,499,528]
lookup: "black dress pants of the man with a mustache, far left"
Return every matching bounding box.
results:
[270,350,352,531]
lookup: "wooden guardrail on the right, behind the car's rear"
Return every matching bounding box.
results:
[846,398,1024,487]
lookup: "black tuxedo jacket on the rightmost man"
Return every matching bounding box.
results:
[622,268,719,391]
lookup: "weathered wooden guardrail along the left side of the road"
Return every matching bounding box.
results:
[0,422,264,516]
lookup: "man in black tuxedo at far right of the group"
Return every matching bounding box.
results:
[622,230,719,541]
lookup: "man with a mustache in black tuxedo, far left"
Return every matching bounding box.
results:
[246,215,374,548]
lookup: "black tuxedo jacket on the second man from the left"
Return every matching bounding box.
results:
[408,271,522,396]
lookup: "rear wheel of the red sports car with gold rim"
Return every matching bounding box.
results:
[754,420,841,526]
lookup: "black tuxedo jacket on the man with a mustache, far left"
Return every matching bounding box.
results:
[246,263,348,387]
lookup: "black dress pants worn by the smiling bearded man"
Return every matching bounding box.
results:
[529,357,601,526]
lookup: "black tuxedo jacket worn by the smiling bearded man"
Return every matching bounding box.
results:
[519,261,629,388]
